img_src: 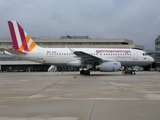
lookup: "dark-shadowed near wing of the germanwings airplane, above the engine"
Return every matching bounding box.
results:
[73,51,115,64]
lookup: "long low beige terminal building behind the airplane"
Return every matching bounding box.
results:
[0,36,149,72]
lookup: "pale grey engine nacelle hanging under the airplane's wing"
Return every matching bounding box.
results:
[99,62,121,72]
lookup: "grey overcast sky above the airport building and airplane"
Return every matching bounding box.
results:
[0,0,160,50]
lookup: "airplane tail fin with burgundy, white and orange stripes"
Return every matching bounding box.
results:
[8,21,36,52]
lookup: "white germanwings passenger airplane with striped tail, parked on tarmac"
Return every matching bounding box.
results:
[4,21,154,75]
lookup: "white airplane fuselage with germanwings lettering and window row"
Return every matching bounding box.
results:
[9,46,154,66]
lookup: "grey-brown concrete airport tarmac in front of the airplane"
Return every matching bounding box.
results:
[0,72,160,120]
